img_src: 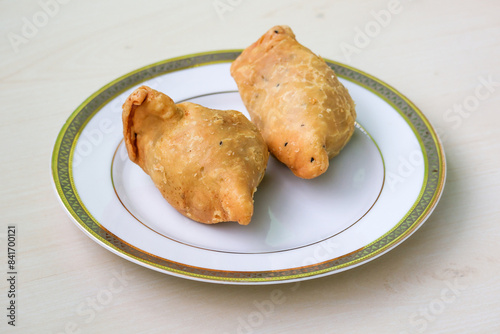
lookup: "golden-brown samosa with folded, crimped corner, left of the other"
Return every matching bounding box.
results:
[122,86,269,225]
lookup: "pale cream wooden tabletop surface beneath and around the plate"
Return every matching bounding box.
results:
[0,0,500,334]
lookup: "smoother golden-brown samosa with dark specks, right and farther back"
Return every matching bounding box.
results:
[231,26,356,179]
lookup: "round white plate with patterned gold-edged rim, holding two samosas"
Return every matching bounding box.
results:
[52,50,446,284]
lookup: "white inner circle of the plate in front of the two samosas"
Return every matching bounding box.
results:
[113,128,384,253]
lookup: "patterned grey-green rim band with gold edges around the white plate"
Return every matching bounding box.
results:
[52,50,446,282]
